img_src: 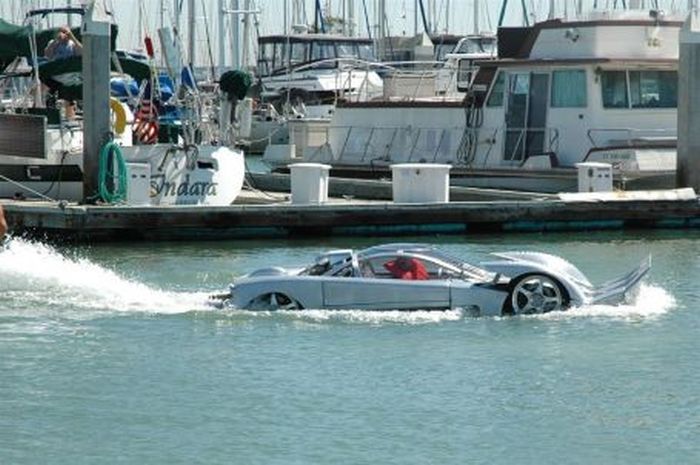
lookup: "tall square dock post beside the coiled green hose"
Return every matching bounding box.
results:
[82,0,111,202]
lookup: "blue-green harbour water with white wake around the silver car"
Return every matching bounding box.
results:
[0,231,700,464]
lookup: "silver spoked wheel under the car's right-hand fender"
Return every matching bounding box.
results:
[506,274,569,315]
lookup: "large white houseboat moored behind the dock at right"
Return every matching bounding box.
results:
[270,11,683,192]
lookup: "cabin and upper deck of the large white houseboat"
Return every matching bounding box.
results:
[472,13,682,166]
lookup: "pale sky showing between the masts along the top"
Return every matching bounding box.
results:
[0,0,695,66]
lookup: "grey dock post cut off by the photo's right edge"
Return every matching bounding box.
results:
[676,9,700,192]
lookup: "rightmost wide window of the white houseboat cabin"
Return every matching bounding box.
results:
[629,71,678,108]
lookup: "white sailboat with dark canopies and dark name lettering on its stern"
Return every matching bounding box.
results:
[0,2,244,205]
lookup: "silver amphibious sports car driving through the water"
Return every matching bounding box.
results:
[220,243,651,315]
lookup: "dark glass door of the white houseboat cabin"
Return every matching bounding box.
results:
[503,73,549,164]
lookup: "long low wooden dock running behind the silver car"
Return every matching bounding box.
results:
[0,190,700,242]
